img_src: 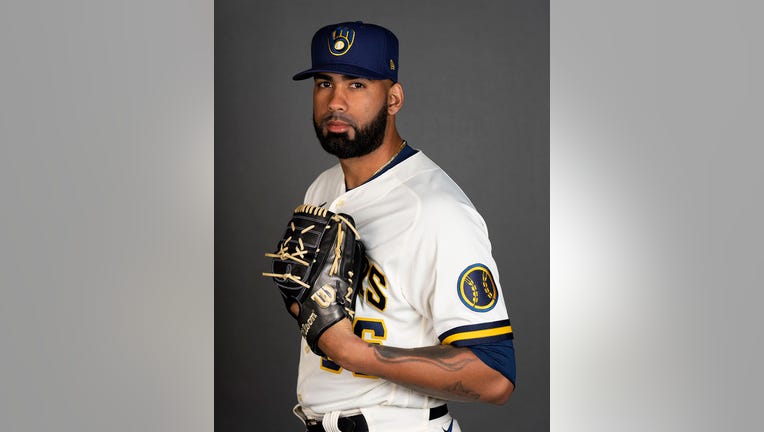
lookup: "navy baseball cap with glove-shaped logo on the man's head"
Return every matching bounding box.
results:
[292,21,398,82]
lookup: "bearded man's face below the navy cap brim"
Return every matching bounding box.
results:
[313,73,391,159]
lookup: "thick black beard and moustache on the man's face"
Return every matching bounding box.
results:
[313,105,387,159]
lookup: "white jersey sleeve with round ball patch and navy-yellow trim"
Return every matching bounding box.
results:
[406,196,512,346]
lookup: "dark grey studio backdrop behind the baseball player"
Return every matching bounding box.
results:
[215,1,549,431]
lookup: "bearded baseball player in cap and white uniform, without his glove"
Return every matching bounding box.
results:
[291,22,515,432]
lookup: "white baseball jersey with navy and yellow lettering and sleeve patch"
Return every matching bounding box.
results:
[297,152,512,417]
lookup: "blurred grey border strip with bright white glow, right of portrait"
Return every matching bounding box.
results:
[550,1,764,432]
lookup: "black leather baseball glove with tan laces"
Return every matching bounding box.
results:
[263,204,368,357]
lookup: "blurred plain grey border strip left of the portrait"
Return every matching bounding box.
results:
[0,0,214,431]
